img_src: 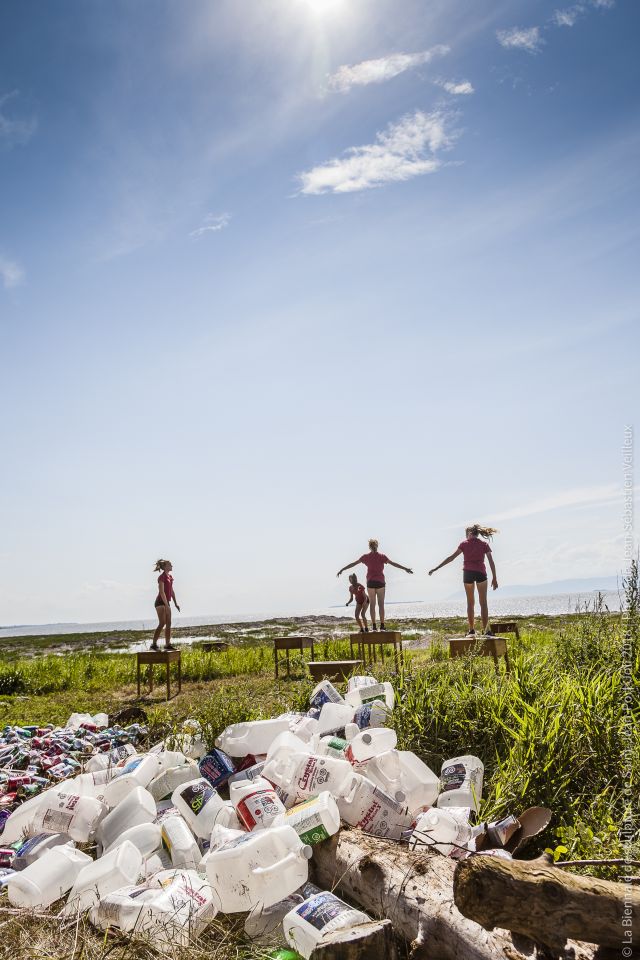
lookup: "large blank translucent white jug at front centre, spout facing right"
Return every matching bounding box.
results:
[207,826,311,913]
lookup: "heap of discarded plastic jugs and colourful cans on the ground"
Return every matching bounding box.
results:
[0,676,496,958]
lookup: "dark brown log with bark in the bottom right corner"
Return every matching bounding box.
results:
[453,854,640,950]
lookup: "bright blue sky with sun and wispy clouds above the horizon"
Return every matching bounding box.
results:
[0,0,640,624]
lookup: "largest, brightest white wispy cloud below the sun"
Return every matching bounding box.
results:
[298,110,458,194]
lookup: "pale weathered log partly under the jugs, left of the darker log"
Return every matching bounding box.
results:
[313,829,594,960]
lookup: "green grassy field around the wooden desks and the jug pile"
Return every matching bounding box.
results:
[0,578,640,960]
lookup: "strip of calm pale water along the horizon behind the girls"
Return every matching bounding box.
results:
[0,592,620,642]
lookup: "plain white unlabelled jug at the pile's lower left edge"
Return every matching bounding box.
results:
[7,845,92,910]
